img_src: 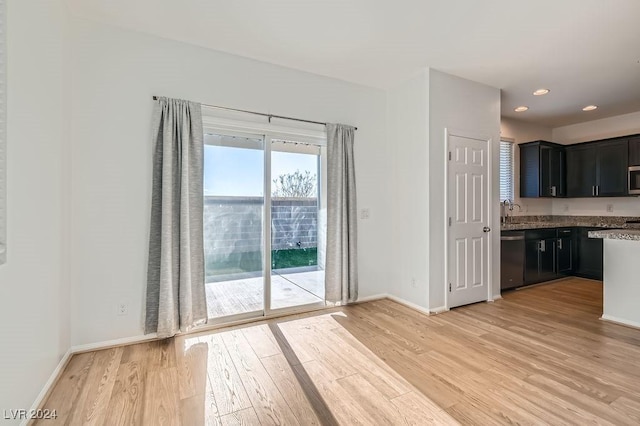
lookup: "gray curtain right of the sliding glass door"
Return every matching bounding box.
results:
[325,124,358,304]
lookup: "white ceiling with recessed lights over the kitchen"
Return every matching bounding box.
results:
[67,0,640,127]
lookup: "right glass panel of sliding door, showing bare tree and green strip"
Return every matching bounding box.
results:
[270,139,325,310]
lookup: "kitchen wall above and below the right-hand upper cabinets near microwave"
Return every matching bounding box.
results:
[551,111,640,216]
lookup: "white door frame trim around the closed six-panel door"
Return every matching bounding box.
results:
[442,127,500,311]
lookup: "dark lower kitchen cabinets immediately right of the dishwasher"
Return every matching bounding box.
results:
[524,228,576,284]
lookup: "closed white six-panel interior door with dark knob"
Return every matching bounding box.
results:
[447,134,490,308]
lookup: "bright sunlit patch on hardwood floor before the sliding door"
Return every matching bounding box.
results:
[183,312,457,424]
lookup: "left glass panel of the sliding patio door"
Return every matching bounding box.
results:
[204,133,265,319]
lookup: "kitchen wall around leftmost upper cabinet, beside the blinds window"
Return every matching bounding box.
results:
[500,117,553,216]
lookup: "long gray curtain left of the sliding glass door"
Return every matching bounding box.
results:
[145,98,207,337]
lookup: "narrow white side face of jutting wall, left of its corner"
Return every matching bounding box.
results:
[386,70,429,308]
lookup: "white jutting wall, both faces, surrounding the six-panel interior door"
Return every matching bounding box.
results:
[388,69,500,311]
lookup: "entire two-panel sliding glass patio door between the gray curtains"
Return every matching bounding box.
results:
[204,131,326,322]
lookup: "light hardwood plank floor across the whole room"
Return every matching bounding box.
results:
[33,279,640,425]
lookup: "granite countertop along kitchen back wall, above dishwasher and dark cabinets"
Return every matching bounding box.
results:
[500,216,640,231]
